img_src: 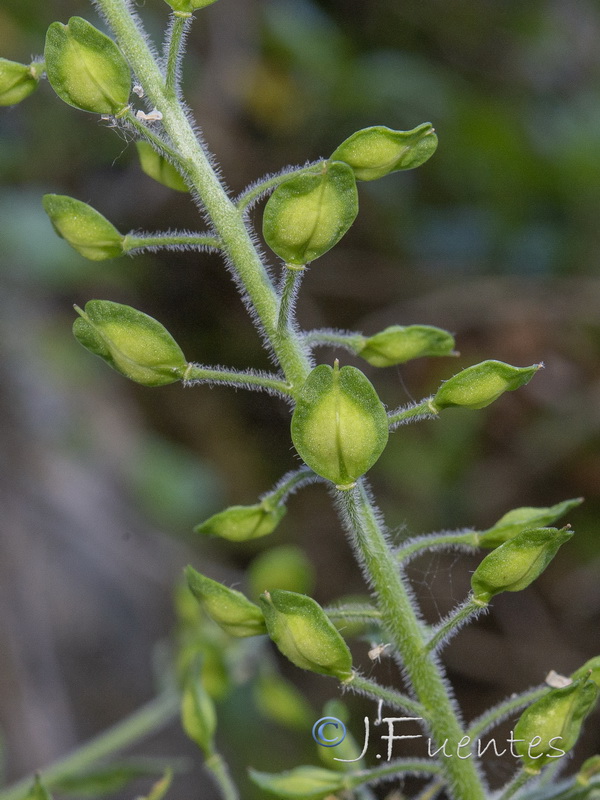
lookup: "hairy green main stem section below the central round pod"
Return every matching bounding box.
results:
[338,479,486,800]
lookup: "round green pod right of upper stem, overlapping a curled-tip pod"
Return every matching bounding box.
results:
[263,161,358,267]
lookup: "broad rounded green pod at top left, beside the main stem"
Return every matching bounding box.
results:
[44,17,131,115]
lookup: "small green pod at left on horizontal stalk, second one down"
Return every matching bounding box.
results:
[42,194,125,261]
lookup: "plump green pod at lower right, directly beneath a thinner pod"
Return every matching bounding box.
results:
[471,528,573,605]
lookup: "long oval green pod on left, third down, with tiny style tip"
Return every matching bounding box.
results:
[73,300,187,386]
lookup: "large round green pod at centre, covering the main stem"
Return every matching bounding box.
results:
[292,361,389,489]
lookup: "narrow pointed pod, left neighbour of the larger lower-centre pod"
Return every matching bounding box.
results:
[185,566,266,637]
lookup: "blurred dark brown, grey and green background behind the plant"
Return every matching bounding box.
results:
[0,0,600,800]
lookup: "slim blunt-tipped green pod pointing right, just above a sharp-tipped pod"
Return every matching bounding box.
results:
[357,325,454,367]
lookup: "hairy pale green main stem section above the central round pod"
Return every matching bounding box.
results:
[97,0,311,387]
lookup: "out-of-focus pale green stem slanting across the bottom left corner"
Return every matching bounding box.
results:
[0,692,179,800]
